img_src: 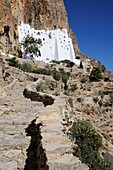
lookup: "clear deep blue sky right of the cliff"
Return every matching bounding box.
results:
[64,0,113,73]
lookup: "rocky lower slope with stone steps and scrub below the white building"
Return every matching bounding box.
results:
[0,56,113,170]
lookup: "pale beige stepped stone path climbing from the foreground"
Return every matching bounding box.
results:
[0,82,88,170]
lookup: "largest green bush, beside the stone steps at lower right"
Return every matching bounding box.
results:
[69,120,111,170]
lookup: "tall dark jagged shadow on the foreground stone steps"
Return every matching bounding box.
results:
[24,119,49,170]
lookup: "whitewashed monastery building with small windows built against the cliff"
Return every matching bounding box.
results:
[18,22,80,65]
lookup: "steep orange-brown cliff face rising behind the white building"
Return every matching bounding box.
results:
[0,0,78,54]
